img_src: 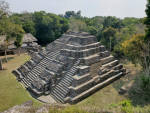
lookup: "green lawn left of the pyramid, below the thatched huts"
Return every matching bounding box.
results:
[0,54,41,112]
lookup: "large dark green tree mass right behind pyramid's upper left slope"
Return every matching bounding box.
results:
[33,11,68,44]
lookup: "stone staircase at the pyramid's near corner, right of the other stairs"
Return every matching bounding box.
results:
[50,60,80,103]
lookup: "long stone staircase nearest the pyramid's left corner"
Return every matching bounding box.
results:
[21,51,59,88]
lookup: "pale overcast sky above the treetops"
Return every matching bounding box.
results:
[5,0,146,18]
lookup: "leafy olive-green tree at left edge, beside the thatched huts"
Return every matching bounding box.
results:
[0,1,24,53]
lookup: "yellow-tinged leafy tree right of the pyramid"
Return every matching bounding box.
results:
[122,34,148,69]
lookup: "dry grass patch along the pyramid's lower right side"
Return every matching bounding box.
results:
[76,85,126,109]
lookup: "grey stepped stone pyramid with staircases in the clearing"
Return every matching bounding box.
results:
[13,32,126,104]
